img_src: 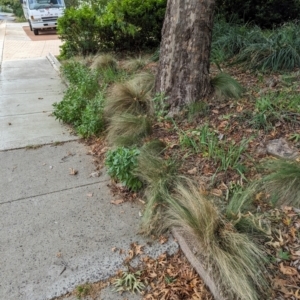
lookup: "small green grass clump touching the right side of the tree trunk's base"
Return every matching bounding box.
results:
[211,73,244,99]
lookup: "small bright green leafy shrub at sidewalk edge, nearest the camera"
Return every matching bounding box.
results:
[105,147,142,191]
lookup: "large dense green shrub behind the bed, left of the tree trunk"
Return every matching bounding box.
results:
[58,0,166,57]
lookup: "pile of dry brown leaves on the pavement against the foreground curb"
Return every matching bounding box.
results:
[116,244,213,300]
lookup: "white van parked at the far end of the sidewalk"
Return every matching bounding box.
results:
[20,0,66,35]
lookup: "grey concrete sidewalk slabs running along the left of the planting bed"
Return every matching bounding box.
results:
[0,21,178,300]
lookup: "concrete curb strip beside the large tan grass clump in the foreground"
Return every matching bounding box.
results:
[172,228,228,300]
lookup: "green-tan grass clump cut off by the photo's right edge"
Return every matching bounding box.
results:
[261,159,300,208]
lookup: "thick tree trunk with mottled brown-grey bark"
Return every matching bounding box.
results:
[155,0,215,113]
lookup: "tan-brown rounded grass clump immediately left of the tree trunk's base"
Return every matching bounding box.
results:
[104,75,153,118]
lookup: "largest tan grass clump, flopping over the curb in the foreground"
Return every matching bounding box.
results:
[167,180,267,300]
